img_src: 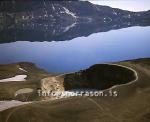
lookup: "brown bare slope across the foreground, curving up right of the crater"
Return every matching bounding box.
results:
[0,59,150,122]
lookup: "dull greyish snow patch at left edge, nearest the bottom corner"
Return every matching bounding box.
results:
[0,100,31,111]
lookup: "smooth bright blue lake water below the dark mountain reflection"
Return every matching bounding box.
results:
[0,27,150,73]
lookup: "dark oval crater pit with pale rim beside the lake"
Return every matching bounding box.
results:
[64,64,137,90]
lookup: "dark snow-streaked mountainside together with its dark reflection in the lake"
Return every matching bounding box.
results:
[0,0,150,43]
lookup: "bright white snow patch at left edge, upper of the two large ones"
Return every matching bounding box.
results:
[0,75,27,82]
